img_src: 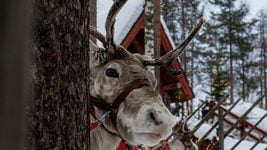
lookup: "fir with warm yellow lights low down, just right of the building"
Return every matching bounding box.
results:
[199,22,229,100]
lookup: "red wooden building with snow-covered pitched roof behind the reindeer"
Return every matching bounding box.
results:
[96,0,194,102]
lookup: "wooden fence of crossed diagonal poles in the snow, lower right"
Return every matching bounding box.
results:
[186,97,267,150]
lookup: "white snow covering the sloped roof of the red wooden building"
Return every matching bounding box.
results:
[97,0,175,48]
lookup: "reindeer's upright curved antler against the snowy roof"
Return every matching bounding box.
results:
[104,0,127,54]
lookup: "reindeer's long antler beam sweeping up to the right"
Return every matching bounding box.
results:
[143,19,204,66]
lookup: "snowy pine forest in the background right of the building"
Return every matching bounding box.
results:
[161,0,267,109]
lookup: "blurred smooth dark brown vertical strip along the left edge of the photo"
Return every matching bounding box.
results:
[0,0,31,150]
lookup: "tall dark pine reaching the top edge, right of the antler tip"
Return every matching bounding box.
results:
[209,0,254,103]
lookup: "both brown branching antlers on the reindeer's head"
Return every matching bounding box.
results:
[90,0,204,68]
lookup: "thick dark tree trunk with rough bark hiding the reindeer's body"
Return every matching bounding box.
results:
[28,0,89,149]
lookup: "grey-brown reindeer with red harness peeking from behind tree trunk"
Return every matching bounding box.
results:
[89,0,203,150]
